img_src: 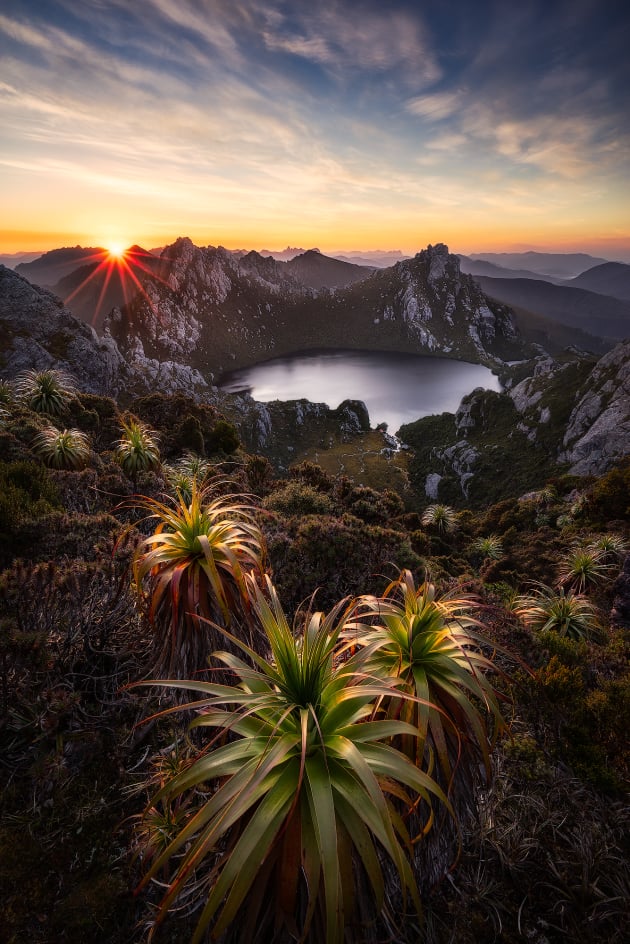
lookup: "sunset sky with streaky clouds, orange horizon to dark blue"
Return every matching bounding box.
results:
[0,0,630,262]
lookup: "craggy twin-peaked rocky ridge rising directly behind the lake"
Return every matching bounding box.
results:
[108,239,522,376]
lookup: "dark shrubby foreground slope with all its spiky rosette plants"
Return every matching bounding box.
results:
[0,376,630,944]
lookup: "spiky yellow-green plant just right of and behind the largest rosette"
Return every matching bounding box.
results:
[347,570,505,787]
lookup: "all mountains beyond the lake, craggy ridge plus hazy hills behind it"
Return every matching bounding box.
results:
[7,239,630,374]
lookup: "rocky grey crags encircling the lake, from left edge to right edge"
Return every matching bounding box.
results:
[0,254,630,480]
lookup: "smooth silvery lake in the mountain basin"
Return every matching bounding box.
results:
[219,351,501,433]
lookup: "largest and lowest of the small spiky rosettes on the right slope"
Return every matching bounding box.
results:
[513,583,599,640]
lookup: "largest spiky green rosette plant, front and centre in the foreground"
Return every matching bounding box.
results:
[135,578,447,944]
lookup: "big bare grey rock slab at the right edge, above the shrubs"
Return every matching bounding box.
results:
[558,340,630,475]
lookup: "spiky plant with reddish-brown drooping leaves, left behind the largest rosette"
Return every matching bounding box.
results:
[133,482,264,678]
